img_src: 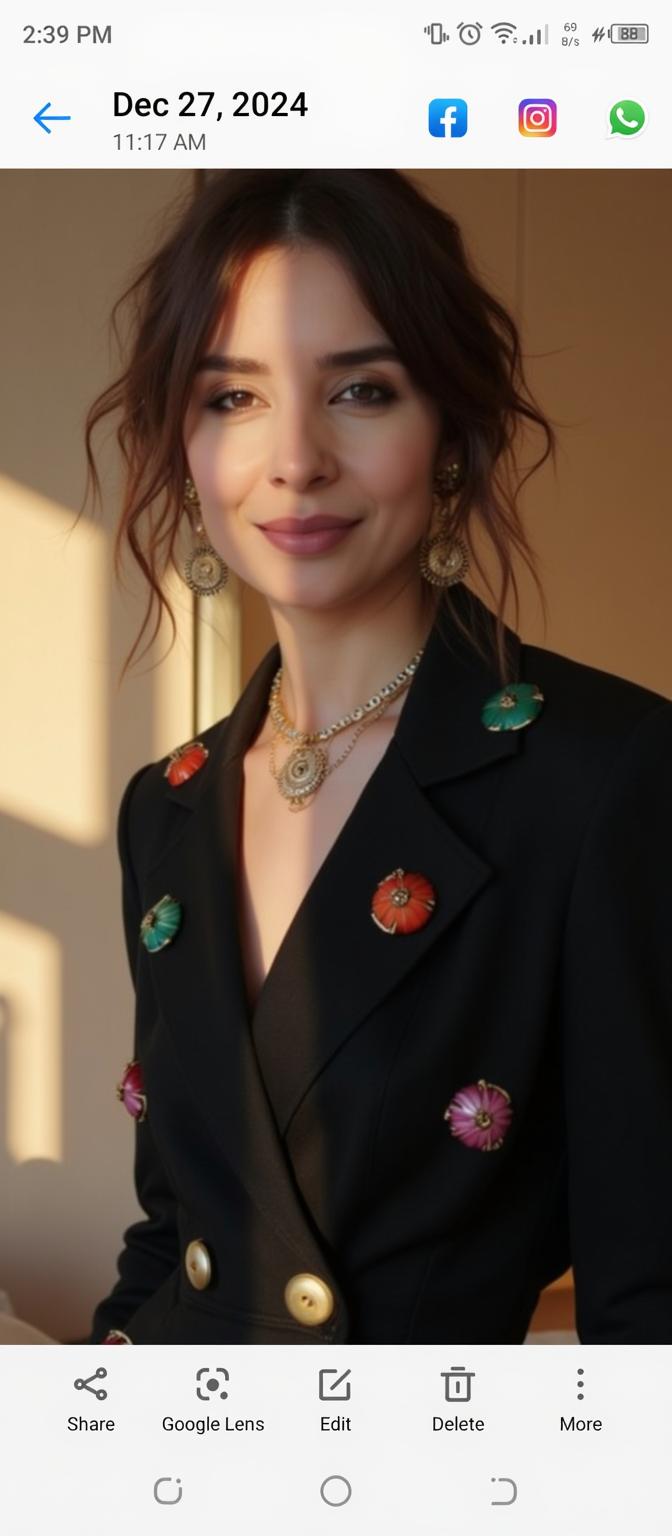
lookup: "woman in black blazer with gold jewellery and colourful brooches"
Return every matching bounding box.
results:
[87,170,672,1344]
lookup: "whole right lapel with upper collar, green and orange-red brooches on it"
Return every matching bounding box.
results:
[252,588,521,1134]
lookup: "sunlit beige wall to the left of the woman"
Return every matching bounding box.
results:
[0,170,192,1338]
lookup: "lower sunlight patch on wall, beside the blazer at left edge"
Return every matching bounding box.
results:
[0,912,63,1163]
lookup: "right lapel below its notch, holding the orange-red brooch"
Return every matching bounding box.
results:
[252,739,491,1132]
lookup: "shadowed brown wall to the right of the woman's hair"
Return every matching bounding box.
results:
[419,170,672,696]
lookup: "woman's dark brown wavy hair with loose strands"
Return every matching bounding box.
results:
[84,170,555,682]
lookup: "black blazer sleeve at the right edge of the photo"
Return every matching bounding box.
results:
[564,702,672,1344]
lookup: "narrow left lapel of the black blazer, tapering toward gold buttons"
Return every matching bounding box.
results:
[143,629,332,1270]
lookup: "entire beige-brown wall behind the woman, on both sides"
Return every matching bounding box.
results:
[0,170,672,1338]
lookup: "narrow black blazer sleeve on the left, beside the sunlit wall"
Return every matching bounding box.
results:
[86,765,180,1344]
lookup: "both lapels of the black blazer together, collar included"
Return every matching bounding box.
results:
[144,588,524,1241]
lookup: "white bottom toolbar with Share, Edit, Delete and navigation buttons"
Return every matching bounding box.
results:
[0,1346,672,1536]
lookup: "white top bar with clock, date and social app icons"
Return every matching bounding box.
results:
[0,0,672,169]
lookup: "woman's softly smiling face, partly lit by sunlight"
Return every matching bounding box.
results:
[184,246,440,608]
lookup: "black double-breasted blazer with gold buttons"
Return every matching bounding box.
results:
[91,587,672,1344]
